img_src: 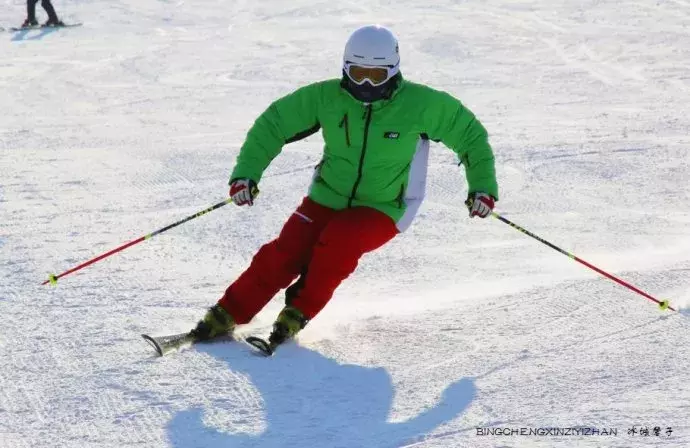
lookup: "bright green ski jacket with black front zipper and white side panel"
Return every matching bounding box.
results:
[230,79,498,231]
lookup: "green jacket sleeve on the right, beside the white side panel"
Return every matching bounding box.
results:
[422,92,498,199]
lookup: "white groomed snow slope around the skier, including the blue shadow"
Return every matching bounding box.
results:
[0,0,690,448]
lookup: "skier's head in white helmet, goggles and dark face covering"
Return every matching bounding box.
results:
[342,25,400,103]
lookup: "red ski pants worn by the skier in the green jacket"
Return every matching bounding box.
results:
[218,198,398,324]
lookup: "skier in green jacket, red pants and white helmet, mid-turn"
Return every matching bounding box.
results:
[190,25,498,350]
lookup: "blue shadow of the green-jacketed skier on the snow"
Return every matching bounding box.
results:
[167,344,476,448]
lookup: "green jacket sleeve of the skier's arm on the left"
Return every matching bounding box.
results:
[230,83,322,184]
